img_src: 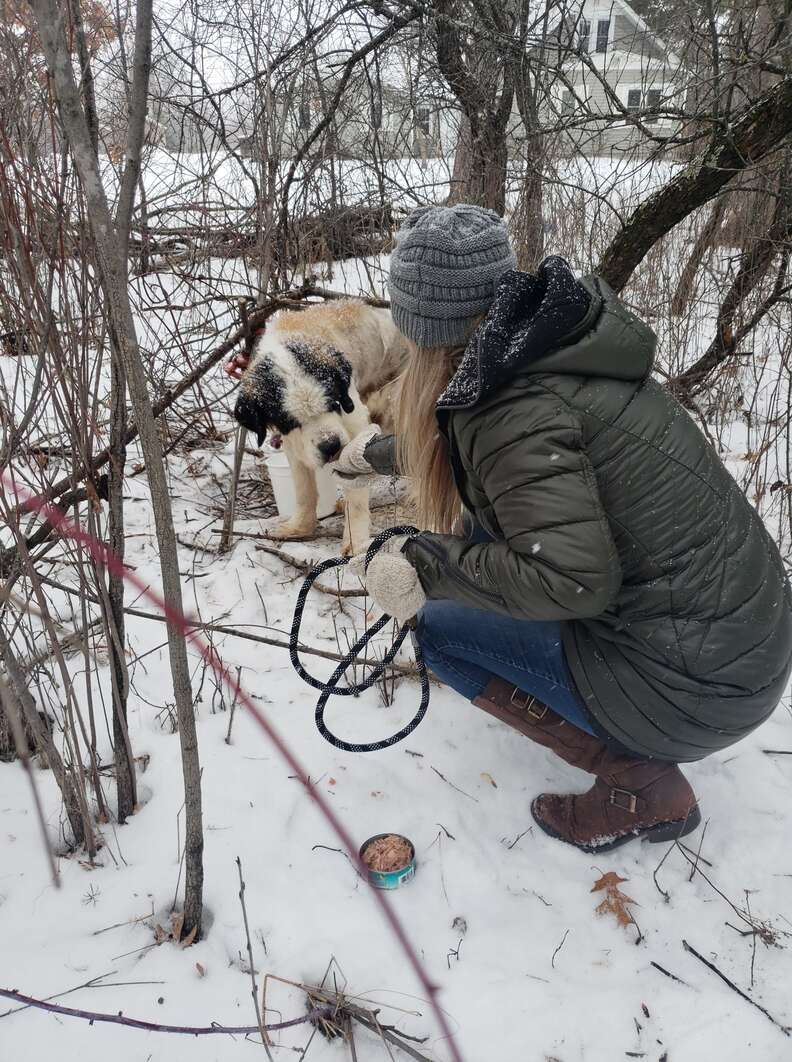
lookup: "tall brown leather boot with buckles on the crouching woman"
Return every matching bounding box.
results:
[472,679,701,852]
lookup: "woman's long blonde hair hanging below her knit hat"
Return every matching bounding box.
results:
[397,342,465,532]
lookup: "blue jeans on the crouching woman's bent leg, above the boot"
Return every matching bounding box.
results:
[415,601,593,734]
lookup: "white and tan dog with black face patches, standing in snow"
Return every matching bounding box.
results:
[234,298,408,556]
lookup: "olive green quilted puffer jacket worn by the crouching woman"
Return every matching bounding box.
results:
[406,259,792,761]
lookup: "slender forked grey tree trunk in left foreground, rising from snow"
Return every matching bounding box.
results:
[31,0,204,936]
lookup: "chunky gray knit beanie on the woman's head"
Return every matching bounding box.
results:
[389,203,517,346]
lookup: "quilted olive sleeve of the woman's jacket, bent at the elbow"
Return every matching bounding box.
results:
[406,392,621,620]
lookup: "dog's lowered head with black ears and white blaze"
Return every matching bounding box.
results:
[234,333,356,467]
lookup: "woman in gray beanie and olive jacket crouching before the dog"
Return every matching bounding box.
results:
[338,205,792,852]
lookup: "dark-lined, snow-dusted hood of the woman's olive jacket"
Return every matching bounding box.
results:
[437,257,657,410]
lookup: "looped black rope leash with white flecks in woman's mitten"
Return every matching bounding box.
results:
[289,527,429,752]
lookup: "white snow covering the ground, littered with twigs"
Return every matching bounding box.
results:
[0,160,792,1062]
